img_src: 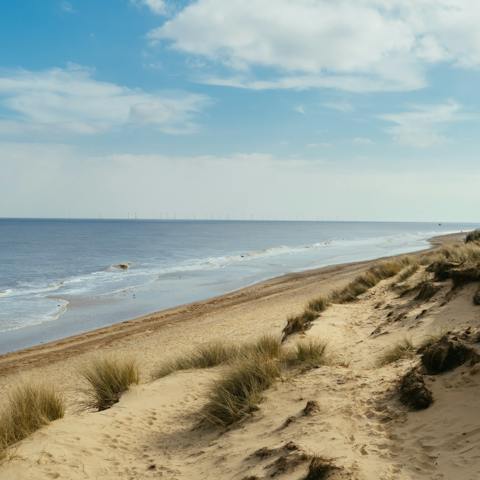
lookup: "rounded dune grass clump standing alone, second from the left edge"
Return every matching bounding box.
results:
[80,357,140,411]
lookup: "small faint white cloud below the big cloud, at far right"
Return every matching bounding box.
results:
[380,100,469,148]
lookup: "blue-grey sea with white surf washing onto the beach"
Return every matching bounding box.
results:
[0,219,476,352]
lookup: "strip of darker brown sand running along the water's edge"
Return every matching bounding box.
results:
[0,232,464,376]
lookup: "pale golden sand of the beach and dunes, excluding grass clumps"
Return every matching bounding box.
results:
[0,231,480,480]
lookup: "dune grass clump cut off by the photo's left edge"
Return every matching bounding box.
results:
[0,384,65,457]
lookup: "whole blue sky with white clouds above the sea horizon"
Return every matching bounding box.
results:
[0,0,480,222]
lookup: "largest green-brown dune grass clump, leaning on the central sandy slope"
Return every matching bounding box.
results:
[203,355,281,427]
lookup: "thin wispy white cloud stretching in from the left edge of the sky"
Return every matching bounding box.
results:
[0,66,208,134]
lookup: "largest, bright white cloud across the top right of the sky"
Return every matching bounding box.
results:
[148,0,480,92]
